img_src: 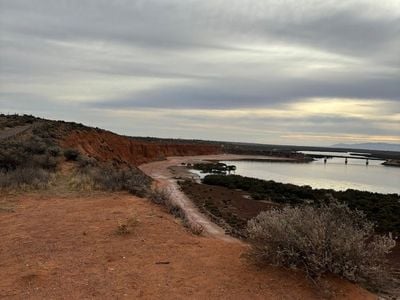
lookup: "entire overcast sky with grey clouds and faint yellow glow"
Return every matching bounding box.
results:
[0,0,400,146]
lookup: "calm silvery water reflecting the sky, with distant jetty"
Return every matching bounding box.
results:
[219,152,400,194]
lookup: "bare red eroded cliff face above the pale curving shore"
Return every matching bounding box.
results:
[61,130,222,166]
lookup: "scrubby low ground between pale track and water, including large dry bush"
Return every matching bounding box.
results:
[181,175,400,293]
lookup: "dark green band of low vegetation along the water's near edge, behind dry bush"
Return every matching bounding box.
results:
[203,175,400,235]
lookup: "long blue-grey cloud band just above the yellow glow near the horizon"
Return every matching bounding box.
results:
[90,76,400,109]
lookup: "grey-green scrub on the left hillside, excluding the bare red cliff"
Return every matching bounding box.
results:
[0,115,151,197]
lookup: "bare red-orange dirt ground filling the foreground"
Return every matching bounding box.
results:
[0,193,376,299]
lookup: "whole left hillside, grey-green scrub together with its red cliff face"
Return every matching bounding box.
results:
[0,114,219,196]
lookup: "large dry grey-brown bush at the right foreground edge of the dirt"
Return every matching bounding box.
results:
[247,199,395,288]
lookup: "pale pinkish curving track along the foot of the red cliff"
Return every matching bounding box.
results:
[139,154,292,242]
